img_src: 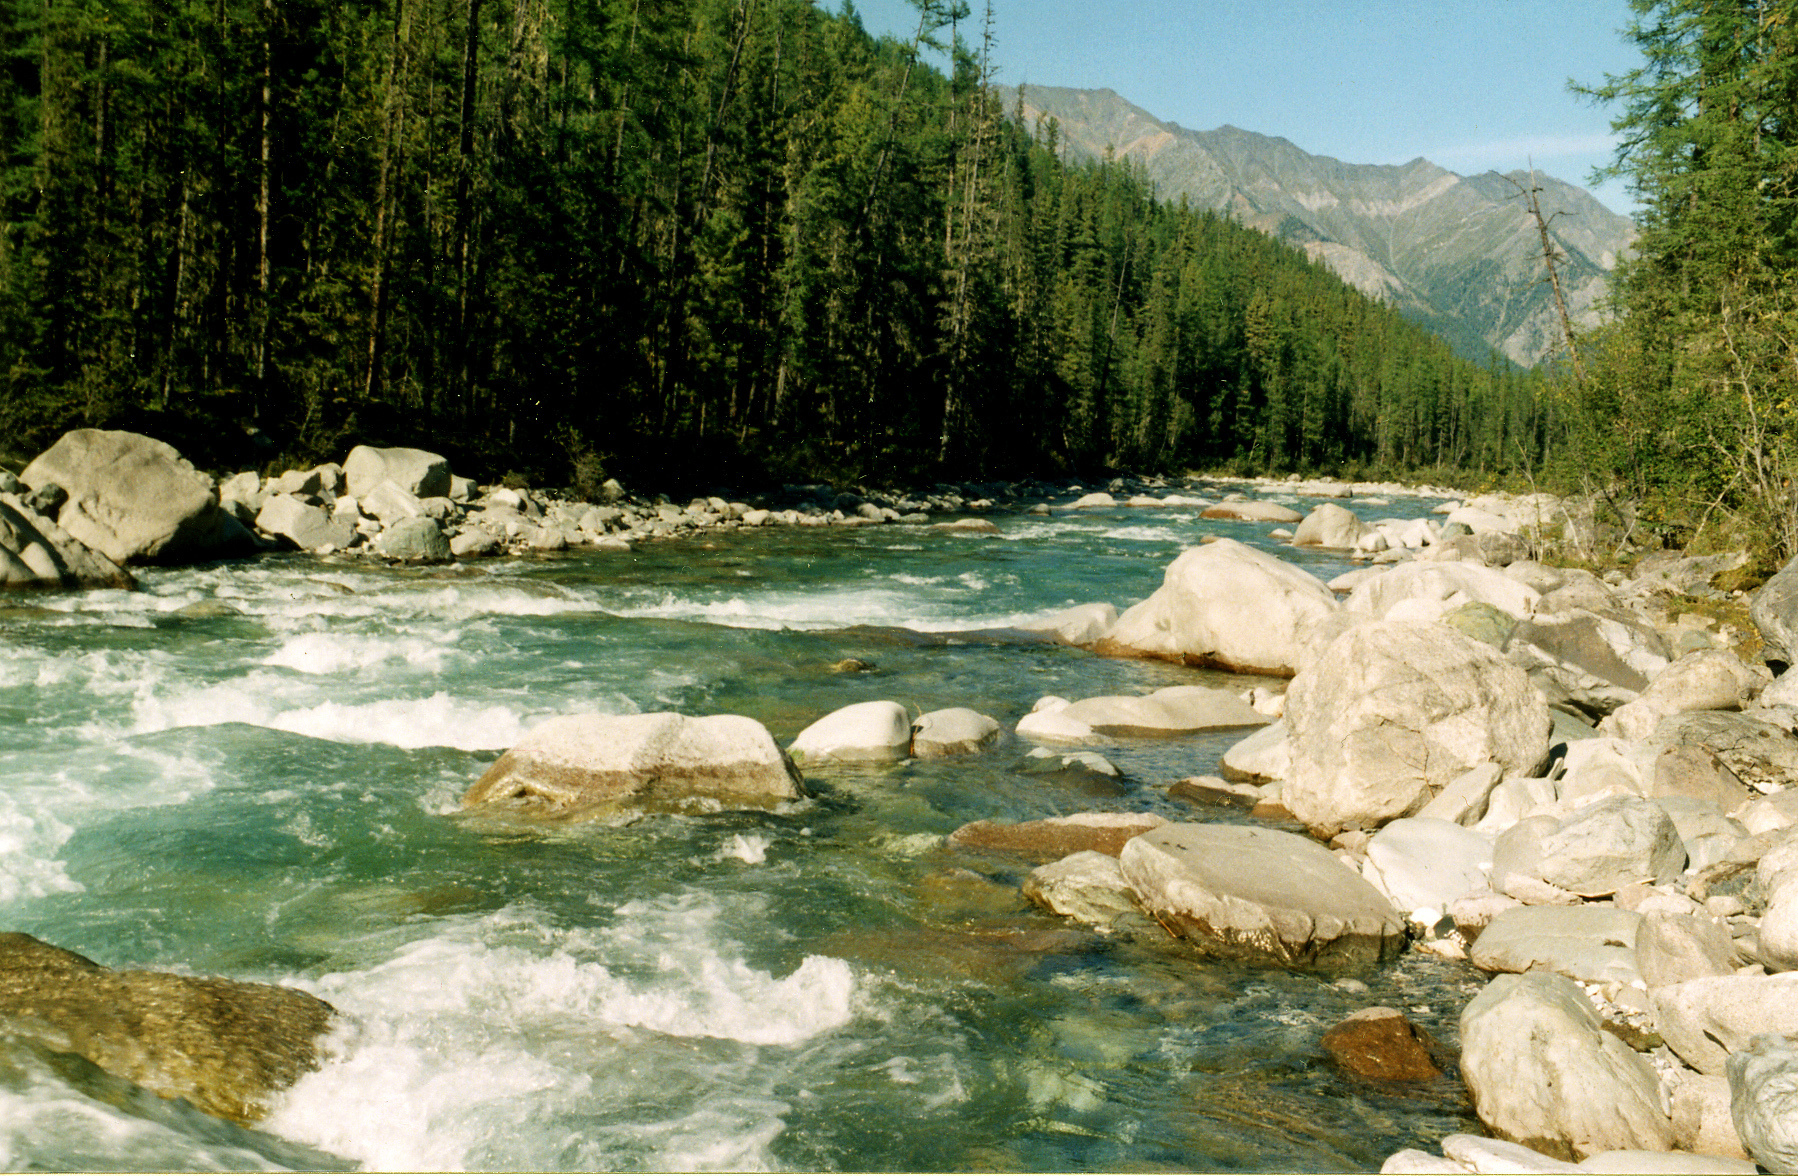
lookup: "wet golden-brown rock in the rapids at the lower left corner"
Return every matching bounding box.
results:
[0,931,333,1124]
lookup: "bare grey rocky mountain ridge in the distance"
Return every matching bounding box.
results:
[1005,86,1636,365]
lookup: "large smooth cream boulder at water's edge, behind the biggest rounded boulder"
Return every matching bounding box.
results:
[1097,539,1336,676]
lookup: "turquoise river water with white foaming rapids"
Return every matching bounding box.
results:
[0,485,1476,1171]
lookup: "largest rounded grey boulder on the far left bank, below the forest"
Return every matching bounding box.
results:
[20,428,254,565]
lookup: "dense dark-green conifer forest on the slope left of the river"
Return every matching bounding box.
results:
[0,0,1564,486]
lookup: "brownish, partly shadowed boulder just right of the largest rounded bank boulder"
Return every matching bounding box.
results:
[1505,611,1669,717]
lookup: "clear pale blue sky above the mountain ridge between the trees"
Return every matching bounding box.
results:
[848,0,1640,212]
